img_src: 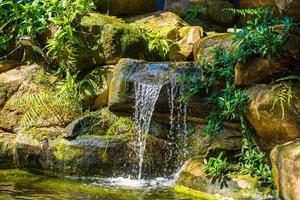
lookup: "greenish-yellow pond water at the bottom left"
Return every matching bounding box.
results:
[0,170,202,200]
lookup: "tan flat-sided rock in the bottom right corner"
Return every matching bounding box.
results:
[271,140,300,200]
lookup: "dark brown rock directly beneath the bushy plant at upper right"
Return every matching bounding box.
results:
[234,57,285,85]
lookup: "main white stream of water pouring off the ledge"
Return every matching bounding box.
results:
[135,81,163,180]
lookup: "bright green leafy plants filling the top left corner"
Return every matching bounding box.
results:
[0,0,93,70]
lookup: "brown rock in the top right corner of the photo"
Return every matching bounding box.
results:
[275,0,300,21]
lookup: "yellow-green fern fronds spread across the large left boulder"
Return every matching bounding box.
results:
[5,73,99,129]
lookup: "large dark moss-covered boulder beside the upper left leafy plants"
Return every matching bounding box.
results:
[46,13,147,70]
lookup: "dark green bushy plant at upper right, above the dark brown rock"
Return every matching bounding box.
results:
[235,8,292,62]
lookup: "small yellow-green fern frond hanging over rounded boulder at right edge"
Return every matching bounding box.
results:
[271,83,293,120]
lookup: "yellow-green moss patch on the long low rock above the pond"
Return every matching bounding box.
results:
[54,141,84,161]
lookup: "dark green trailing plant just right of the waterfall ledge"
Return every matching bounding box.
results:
[181,48,248,135]
